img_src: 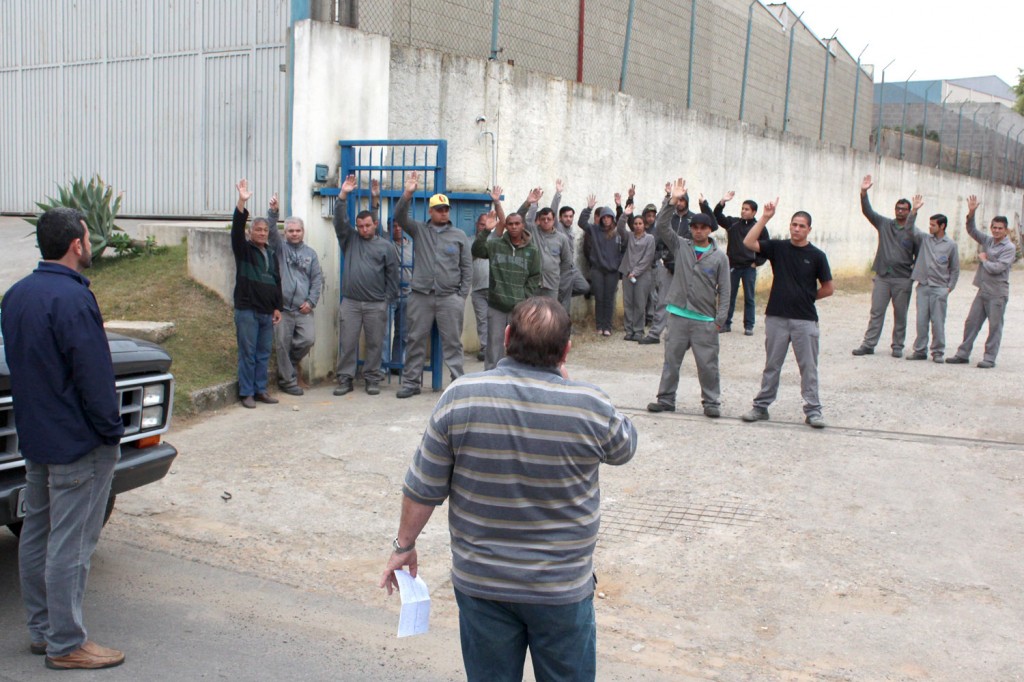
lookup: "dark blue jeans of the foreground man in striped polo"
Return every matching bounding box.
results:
[455,590,597,682]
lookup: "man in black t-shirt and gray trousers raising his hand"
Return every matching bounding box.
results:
[742,199,835,429]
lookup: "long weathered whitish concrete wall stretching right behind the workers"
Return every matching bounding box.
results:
[388,45,1024,281]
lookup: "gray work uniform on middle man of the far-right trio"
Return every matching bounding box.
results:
[910,229,959,360]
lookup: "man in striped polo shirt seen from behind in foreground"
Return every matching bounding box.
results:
[380,296,637,681]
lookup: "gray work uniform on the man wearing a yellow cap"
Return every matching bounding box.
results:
[394,197,473,388]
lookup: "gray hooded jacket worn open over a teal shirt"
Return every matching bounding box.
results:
[654,205,730,327]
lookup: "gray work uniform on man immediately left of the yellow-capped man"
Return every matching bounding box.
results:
[334,199,400,386]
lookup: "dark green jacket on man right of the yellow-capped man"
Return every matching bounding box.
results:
[472,229,541,312]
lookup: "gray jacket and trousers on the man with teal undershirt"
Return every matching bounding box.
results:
[655,205,729,408]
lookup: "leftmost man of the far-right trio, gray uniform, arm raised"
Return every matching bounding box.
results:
[853,175,924,357]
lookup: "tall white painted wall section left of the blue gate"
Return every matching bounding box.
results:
[283,20,391,379]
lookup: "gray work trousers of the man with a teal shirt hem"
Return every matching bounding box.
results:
[657,314,722,408]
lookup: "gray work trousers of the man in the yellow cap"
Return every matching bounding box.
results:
[401,291,466,388]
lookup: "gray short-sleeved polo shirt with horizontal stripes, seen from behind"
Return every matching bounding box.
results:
[404,357,637,604]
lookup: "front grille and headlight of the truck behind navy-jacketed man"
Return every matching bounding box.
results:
[0,374,174,471]
